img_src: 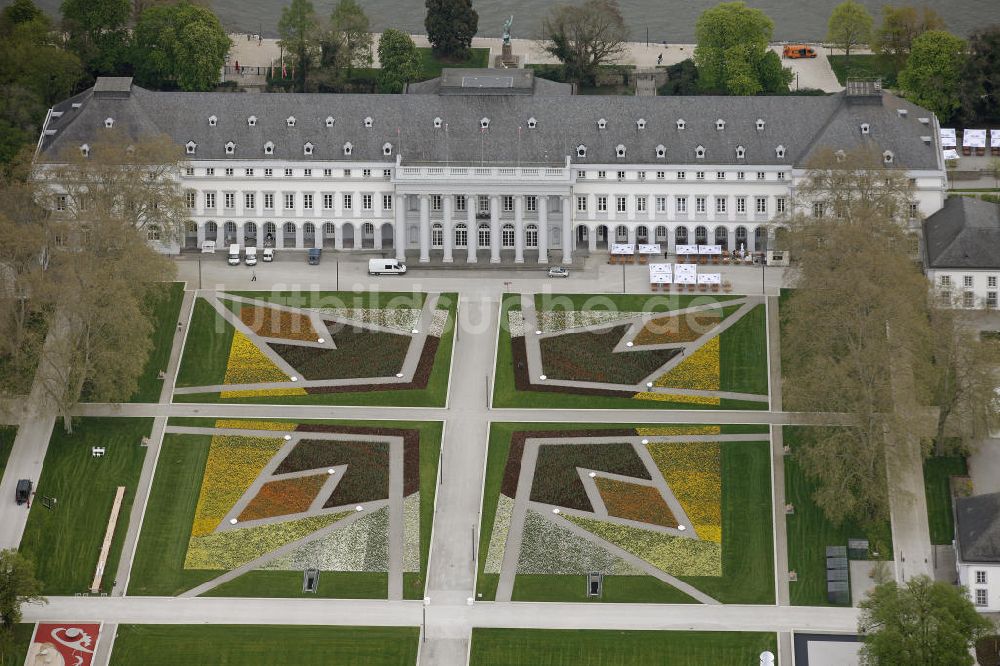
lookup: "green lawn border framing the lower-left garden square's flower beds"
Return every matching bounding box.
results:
[128,417,443,599]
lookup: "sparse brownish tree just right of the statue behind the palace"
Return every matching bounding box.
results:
[542,0,628,85]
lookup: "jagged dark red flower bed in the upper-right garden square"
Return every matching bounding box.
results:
[539,325,684,384]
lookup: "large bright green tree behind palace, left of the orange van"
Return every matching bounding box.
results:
[694,2,792,95]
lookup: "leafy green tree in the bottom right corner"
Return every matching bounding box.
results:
[858,576,994,666]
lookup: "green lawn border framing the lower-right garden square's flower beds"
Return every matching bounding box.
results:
[476,423,774,604]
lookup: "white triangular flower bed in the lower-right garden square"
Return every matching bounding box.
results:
[517,509,644,576]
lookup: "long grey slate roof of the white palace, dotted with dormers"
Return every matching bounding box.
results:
[40,75,938,169]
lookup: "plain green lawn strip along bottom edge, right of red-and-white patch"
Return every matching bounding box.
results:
[111,624,420,666]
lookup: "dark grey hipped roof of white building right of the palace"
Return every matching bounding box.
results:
[924,197,1000,269]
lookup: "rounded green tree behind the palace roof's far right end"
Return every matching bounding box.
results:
[899,30,965,122]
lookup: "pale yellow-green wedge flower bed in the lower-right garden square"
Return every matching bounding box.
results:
[562,514,722,576]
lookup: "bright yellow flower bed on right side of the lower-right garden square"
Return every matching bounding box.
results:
[648,442,722,543]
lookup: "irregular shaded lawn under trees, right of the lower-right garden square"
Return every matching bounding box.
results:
[784,426,892,606]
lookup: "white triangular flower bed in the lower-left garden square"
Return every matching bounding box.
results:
[261,507,389,571]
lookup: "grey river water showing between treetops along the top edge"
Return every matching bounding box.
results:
[25,0,1000,43]
